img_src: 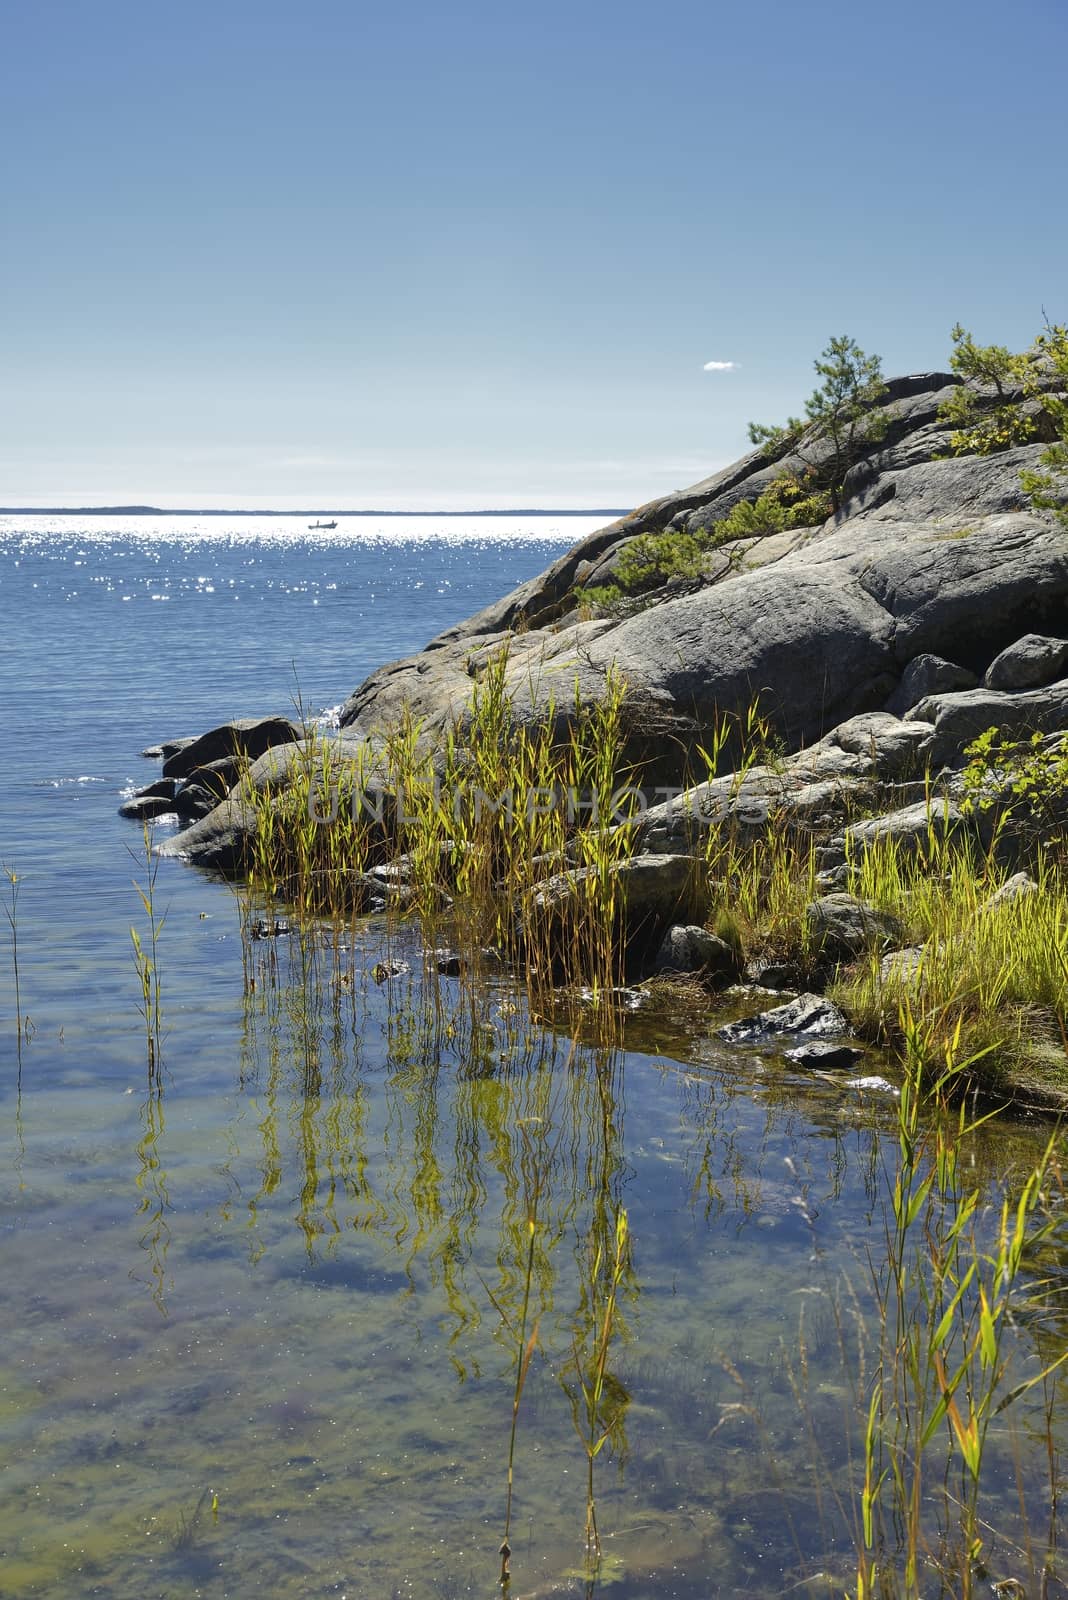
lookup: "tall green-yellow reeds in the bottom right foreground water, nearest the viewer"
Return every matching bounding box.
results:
[855,1008,1068,1600]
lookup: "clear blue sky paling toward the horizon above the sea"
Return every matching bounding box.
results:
[0,0,1068,509]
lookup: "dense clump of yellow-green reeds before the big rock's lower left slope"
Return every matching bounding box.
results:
[238,653,630,1003]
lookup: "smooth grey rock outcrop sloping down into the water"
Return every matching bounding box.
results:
[123,373,1068,1104]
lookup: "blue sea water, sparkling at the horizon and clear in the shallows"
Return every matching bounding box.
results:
[0,518,1065,1600]
